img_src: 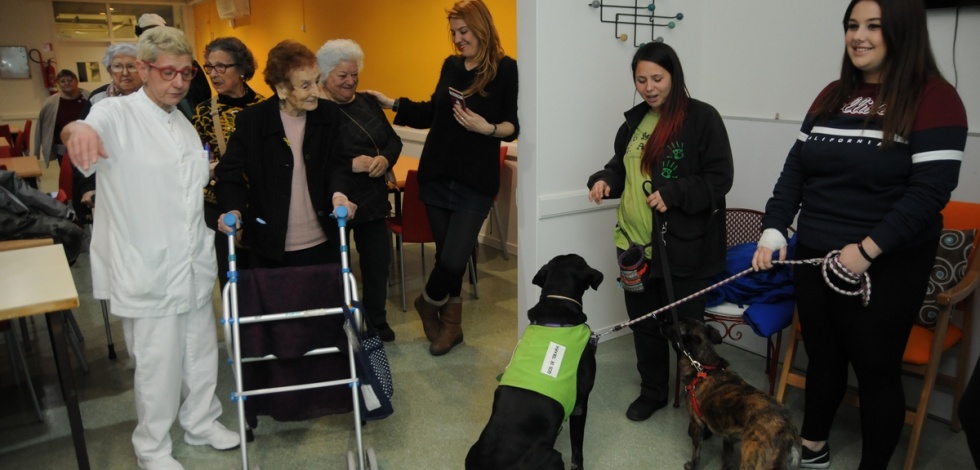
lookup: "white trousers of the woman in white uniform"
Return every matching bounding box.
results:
[122,302,221,461]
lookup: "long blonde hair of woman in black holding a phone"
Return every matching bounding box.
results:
[446,0,504,96]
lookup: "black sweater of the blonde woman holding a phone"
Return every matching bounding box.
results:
[395,56,520,197]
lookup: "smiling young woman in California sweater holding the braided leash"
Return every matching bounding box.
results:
[753,0,967,469]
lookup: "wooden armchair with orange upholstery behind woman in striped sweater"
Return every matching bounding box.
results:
[776,201,980,470]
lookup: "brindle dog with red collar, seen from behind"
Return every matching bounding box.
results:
[664,319,802,470]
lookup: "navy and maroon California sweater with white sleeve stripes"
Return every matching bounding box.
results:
[762,77,967,252]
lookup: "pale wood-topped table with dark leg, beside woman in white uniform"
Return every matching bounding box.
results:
[0,244,90,470]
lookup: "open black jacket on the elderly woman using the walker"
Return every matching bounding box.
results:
[214,97,348,260]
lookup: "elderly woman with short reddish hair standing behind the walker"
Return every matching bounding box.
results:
[215,40,356,268]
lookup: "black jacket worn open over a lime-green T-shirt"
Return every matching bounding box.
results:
[588,99,734,278]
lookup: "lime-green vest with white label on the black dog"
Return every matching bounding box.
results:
[500,324,592,419]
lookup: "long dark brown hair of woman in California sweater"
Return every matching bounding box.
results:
[812,0,942,147]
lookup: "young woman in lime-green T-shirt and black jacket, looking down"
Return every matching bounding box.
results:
[588,42,734,421]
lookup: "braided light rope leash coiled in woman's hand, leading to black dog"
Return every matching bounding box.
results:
[596,246,871,338]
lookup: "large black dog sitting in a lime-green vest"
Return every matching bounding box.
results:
[466,254,602,470]
